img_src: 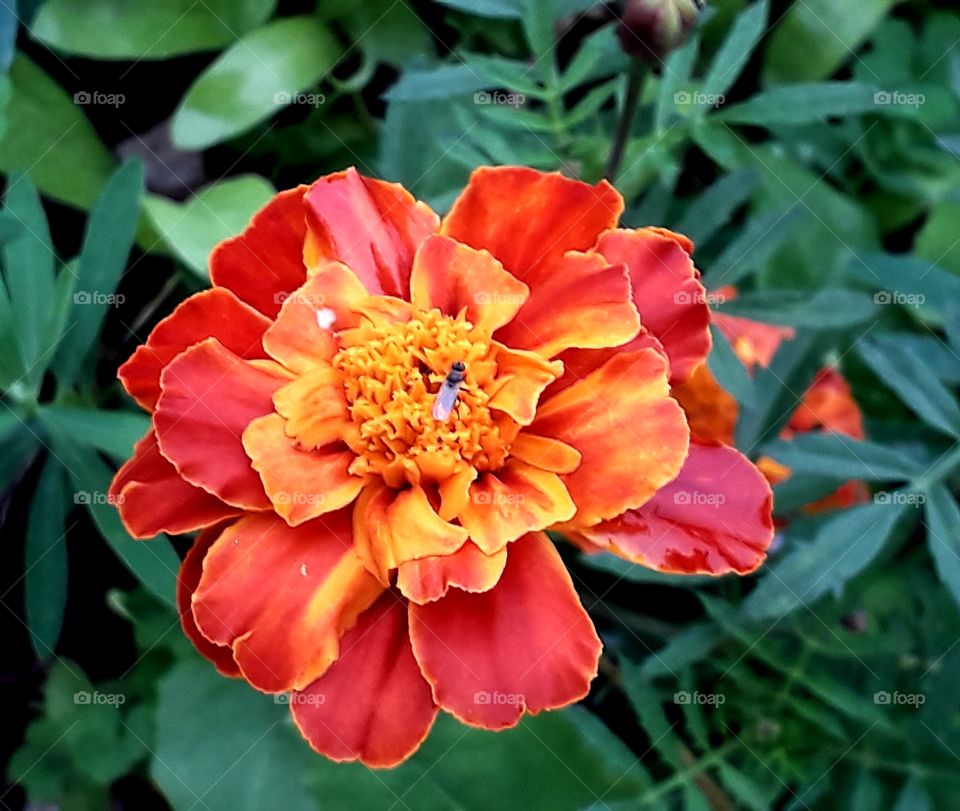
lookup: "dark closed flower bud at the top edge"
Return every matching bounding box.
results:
[617,0,704,66]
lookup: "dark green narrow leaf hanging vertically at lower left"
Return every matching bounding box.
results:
[23,458,70,660]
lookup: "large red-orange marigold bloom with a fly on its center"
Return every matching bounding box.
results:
[112,167,773,766]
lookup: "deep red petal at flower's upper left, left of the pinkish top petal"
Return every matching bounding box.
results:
[210,186,307,318]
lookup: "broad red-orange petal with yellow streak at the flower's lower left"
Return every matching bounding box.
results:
[193,511,383,693]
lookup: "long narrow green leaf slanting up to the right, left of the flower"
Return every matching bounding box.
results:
[55,161,144,385]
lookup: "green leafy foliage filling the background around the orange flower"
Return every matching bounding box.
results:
[0,0,960,811]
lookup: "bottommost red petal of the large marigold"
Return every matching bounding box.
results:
[290,592,437,768]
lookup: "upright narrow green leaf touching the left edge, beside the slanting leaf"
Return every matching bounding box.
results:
[3,174,56,381]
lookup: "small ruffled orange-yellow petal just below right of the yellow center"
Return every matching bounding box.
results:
[458,459,577,555]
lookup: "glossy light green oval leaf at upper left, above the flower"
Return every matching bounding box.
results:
[171,17,342,149]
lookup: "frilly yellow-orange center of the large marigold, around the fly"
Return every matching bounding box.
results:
[333,310,513,486]
